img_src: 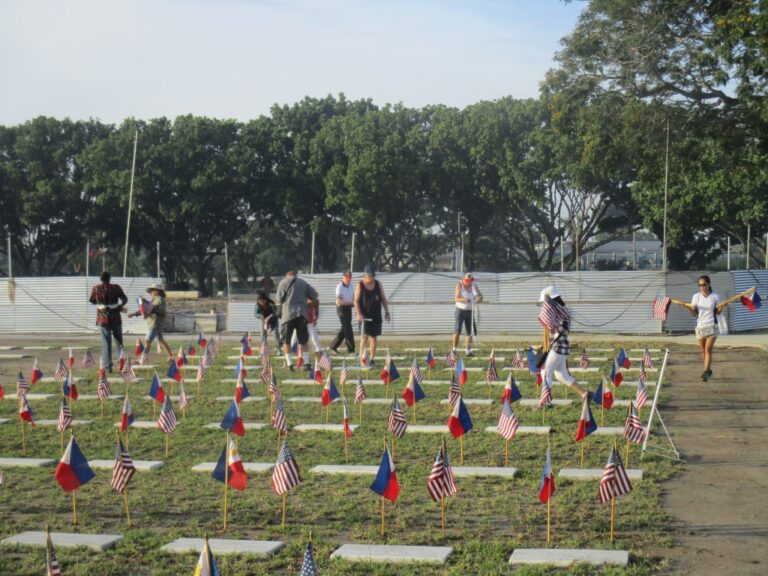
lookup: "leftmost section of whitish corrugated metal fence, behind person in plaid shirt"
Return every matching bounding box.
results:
[0,276,159,334]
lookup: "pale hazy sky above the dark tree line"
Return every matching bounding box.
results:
[0,0,584,125]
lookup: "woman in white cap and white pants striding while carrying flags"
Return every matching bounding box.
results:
[539,286,588,398]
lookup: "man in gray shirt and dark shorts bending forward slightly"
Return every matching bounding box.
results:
[276,270,320,370]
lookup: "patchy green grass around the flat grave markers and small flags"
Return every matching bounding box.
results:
[0,338,675,576]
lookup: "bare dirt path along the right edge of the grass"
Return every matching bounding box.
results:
[662,346,768,576]
